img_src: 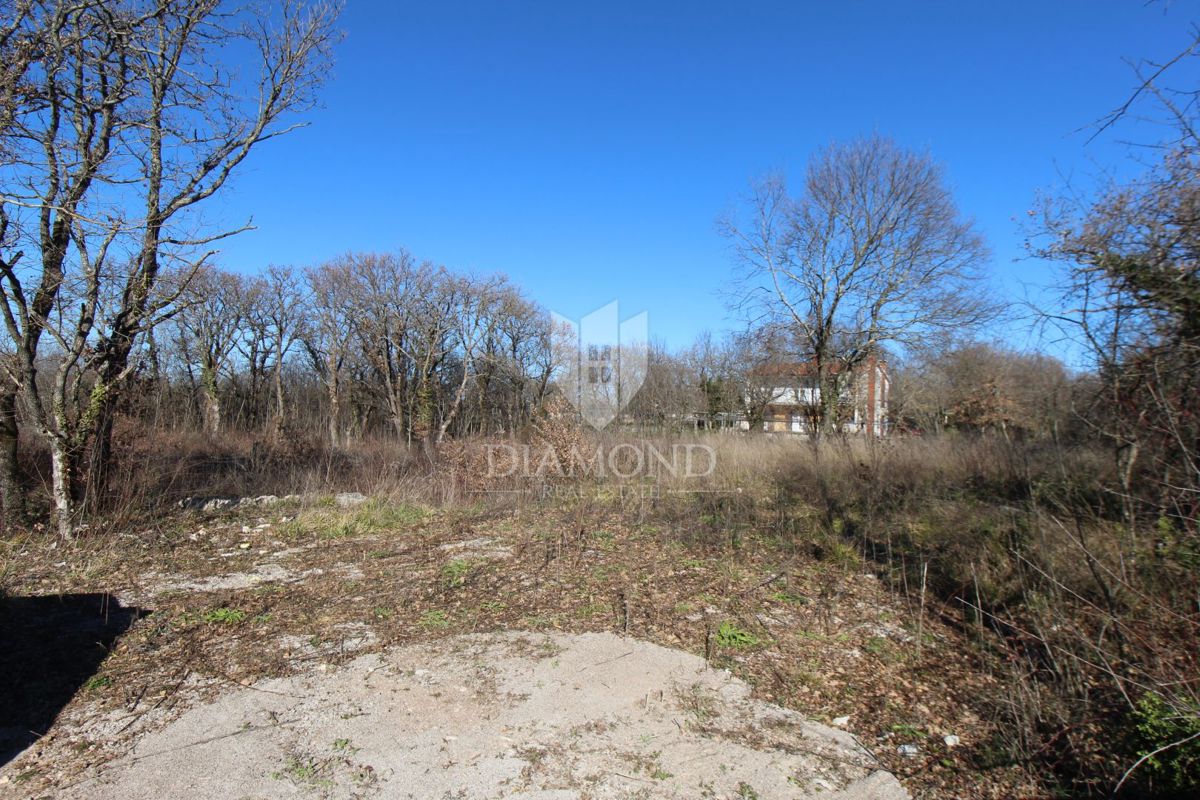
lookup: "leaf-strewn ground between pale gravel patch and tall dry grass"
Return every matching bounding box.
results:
[0,494,1030,798]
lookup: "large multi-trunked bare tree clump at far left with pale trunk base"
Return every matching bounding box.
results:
[0,0,337,536]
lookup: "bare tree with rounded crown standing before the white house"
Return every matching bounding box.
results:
[720,136,995,431]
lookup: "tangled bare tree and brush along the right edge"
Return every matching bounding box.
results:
[1033,35,1200,795]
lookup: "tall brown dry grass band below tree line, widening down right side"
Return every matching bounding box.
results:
[14,410,1200,796]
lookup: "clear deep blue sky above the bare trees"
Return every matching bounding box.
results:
[209,0,1200,364]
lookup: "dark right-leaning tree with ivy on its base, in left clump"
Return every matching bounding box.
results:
[91,0,338,503]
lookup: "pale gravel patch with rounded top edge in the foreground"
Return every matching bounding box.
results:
[62,628,908,800]
